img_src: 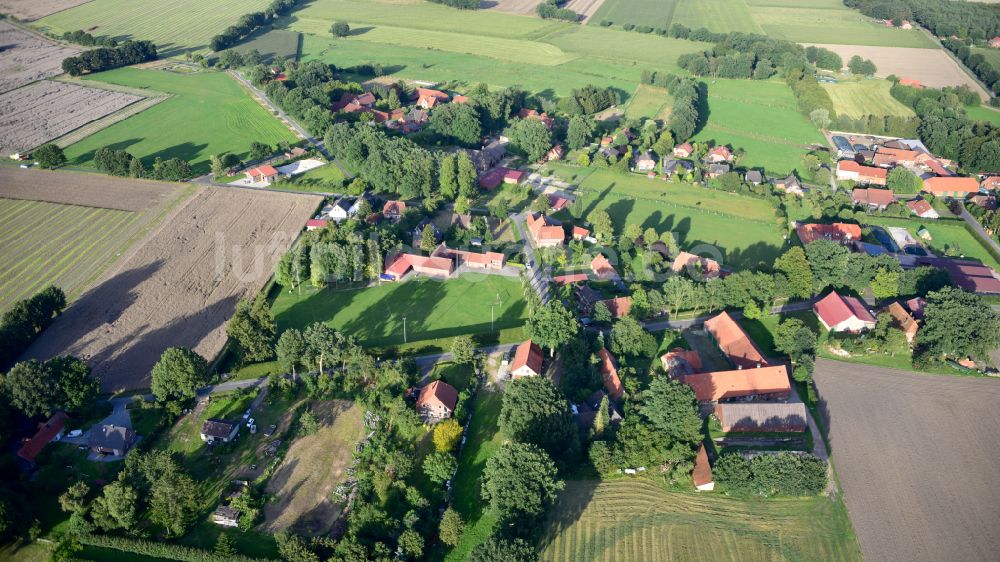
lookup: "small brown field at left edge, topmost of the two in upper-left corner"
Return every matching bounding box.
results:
[0,21,80,93]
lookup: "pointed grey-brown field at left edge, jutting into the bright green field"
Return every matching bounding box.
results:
[0,80,143,154]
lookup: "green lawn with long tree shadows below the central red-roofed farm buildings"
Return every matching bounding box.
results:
[273,273,527,347]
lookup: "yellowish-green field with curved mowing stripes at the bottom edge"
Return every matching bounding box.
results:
[541,479,861,562]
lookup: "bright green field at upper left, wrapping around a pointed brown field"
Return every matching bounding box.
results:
[66,68,297,173]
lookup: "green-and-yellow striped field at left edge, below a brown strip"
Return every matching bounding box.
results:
[0,199,146,311]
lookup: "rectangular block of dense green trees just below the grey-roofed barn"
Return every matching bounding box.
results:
[712,452,827,497]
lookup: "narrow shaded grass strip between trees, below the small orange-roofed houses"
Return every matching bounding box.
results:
[440,390,503,562]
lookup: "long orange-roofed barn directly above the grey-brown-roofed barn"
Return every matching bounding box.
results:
[681,365,792,402]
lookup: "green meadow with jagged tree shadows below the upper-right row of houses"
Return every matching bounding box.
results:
[571,170,785,265]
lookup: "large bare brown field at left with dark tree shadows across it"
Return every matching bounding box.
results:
[26,183,321,391]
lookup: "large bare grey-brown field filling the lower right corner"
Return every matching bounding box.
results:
[815,359,1000,562]
